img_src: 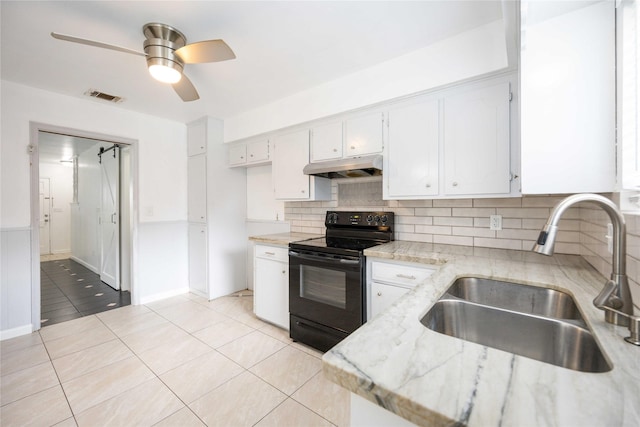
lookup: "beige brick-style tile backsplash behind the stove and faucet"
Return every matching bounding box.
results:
[285,179,640,305]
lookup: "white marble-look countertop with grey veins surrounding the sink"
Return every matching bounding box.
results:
[323,241,640,427]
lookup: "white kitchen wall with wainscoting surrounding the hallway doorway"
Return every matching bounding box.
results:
[0,80,188,331]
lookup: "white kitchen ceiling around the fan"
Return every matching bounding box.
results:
[0,0,501,122]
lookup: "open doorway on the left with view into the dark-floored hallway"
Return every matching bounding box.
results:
[30,123,137,329]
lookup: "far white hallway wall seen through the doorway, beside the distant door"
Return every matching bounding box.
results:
[40,162,73,254]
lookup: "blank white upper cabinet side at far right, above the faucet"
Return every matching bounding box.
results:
[520,1,618,194]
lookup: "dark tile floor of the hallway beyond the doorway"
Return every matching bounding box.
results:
[40,259,131,326]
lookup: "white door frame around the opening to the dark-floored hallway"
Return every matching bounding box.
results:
[29,122,140,331]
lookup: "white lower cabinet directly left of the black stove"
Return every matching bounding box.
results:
[253,244,289,330]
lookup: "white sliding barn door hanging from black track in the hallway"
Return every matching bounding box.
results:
[100,147,120,289]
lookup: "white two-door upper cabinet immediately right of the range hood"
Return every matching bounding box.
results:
[382,73,519,200]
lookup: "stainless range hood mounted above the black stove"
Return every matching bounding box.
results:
[302,154,382,178]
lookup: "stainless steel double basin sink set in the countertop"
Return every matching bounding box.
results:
[420,277,612,372]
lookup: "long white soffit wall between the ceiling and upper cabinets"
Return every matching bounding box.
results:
[224,20,508,142]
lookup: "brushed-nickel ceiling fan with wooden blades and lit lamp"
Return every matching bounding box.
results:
[51,22,236,102]
